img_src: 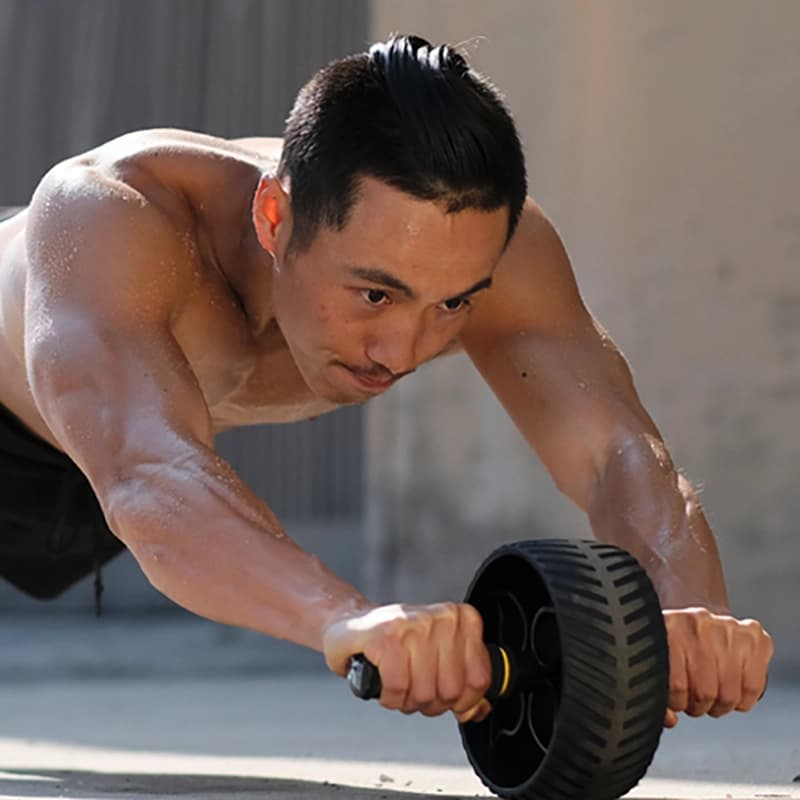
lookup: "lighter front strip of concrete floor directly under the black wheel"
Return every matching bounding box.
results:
[0,675,800,800]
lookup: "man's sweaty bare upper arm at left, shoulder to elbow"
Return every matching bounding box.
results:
[25,171,211,496]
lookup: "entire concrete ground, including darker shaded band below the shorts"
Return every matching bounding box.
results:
[0,611,800,800]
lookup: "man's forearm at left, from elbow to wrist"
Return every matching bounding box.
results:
[102,447,370,651]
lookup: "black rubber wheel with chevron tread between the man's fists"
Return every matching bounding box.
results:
[459,539,669,800]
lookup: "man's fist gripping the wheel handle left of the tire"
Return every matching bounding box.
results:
[323,603,491,723]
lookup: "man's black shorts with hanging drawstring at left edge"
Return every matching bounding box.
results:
[0,405,125,600]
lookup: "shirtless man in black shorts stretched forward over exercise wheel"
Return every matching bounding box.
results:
[0,37,772,725]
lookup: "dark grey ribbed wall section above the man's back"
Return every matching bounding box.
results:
[0,0,369,205]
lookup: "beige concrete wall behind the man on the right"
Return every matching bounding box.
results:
[367,0,800,673]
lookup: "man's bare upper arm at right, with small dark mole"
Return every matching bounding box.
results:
[465,200,658,507]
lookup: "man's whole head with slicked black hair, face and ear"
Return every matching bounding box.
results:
[254,36,526,402]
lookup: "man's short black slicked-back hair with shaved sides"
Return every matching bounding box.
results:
[278,35,526,251]
